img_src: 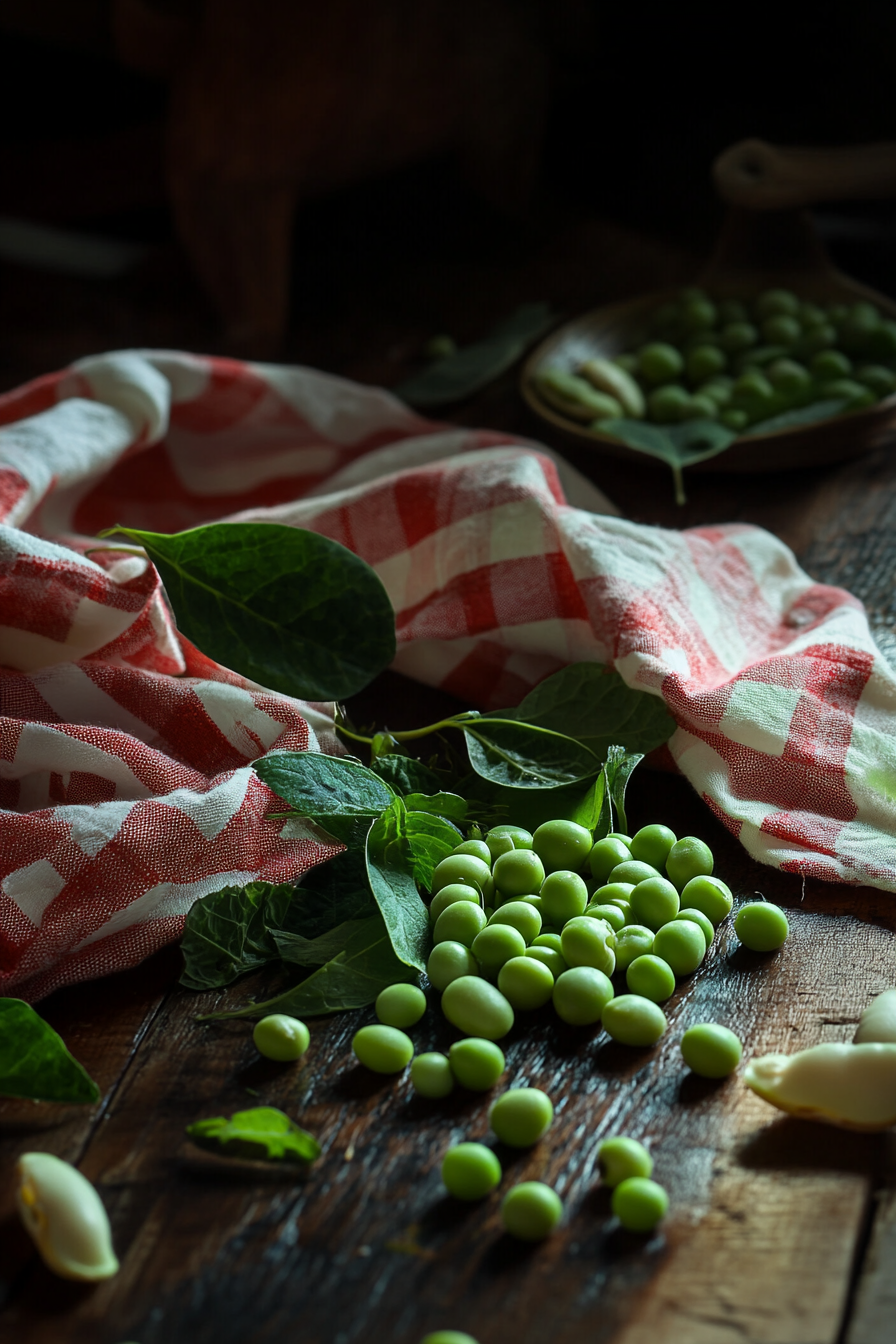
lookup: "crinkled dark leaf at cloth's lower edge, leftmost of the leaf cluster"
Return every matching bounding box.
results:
[180,882,286,989]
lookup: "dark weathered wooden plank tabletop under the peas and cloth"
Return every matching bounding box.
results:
[0,159,896,1344]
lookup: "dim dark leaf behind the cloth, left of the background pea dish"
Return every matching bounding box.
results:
[395,304,555,407]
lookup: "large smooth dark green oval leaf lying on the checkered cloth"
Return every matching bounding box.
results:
[103,523,395,700]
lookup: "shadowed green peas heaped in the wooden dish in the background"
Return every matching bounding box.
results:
[545,288,896,433]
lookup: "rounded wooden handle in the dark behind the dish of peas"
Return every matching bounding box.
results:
[712,140,896,210]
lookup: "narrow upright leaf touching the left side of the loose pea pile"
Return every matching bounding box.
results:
[367,798,430,970]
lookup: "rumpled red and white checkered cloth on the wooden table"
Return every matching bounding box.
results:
[0,351,896,999]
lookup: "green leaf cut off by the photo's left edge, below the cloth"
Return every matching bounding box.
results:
[0,999,99,1105]
